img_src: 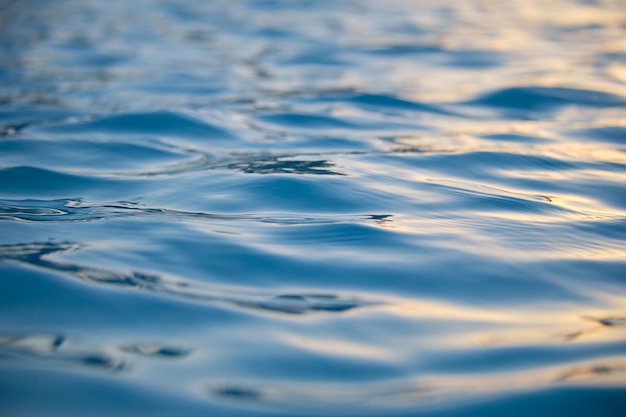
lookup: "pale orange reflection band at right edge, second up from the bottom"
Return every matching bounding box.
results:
[377,293,626,348]
